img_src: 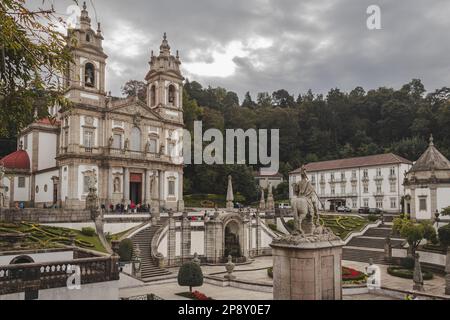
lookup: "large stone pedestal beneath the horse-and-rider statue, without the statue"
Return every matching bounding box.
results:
[270,233,344,300]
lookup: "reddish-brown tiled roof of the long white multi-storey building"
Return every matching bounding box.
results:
[291,153,412,173]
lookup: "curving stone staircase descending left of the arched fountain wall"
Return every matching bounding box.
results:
[131,224,170,281]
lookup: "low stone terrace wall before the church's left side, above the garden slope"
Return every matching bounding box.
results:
[0,208,91,223]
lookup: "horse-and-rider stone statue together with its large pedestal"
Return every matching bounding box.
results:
[270,168,344,300]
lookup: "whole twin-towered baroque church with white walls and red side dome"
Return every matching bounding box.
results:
[0,5,184,212]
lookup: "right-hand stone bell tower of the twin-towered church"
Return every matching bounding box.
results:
[145,33,184,123]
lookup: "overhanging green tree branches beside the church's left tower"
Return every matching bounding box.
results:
[0,0,72,138]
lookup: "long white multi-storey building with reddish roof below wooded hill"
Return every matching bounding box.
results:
[289,153,412,212]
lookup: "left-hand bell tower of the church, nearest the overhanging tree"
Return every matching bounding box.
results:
[65,2,107,107]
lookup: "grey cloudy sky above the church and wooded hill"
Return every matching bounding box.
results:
[35,0,450,97]
